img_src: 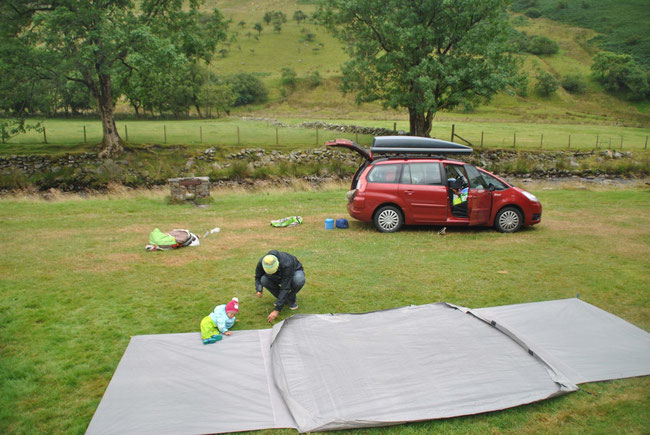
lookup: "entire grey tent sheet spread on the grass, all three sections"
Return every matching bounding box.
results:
[87,299,650,434]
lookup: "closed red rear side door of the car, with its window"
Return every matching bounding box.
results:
[398,162,447,223]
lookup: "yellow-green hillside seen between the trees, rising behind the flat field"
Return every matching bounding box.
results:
[189,0,650,127]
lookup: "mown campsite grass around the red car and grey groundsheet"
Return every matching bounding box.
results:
[0,184,650,434]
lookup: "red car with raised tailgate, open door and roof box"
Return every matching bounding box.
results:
[326,136,542,233]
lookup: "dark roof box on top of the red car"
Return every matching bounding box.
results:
[370,136,472,155]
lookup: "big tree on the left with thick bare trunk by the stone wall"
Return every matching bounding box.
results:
[0,0,225,157]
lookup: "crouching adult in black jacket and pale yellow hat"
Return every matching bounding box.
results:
[255,250,305,323]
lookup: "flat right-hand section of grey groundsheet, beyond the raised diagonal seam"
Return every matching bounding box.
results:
[472,299,650,384]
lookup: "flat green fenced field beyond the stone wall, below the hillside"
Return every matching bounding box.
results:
[0,118,650,155]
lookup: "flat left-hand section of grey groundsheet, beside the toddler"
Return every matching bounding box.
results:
[86,329,296,435]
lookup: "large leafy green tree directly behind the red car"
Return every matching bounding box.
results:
[316,0,519,136]
